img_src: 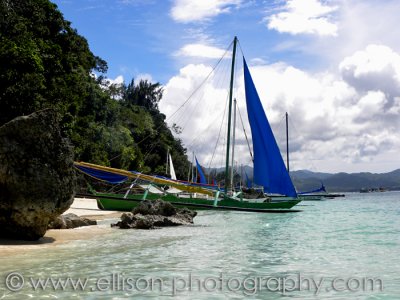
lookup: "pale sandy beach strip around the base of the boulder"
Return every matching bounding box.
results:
[0,198,121,256]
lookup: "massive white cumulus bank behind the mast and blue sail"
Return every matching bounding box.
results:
[160,45,400,172]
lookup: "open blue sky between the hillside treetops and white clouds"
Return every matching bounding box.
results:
[53,0,326,83]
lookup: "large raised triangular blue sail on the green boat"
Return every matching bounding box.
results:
[243,57,297,197]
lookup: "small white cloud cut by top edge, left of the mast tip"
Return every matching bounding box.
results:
[171,0,242,23]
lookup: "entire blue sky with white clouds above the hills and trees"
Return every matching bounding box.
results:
[53,0,400,172]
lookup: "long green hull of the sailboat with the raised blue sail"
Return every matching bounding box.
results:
[95,193,301,212]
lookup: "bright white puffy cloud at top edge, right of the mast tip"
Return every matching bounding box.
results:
[267,0,338,36]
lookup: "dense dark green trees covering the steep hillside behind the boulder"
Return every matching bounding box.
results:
[0,0,188,178]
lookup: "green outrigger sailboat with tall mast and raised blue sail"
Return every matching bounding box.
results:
[75,37,301,213]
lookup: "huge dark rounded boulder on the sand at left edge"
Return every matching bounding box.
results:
[0,109,76,240]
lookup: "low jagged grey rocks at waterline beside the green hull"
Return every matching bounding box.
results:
[111,200,197,229]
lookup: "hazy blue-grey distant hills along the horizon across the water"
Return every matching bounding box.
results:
[205,166,400,192]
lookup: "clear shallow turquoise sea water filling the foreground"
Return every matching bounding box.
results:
[0,192,400,299]
